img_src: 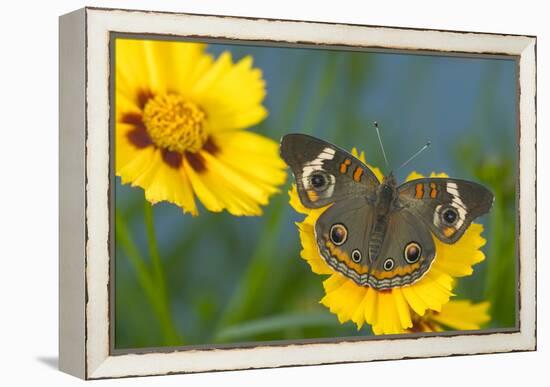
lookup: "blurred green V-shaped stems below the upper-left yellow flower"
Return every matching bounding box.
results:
[116,206,183,345]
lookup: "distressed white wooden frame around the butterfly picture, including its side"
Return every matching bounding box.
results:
[59,8,536,379]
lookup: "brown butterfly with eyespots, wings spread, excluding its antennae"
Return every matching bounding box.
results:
[281,134,493,290]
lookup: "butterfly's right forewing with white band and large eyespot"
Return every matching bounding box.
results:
[398,178,493,243]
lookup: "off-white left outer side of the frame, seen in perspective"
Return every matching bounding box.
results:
[58,8,86,379]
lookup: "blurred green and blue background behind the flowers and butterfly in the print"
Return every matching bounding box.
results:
[115,45,517,349]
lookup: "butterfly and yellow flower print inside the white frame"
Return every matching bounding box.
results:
[114,34,518,350]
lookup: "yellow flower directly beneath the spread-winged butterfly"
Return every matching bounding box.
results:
[289,148,485,334]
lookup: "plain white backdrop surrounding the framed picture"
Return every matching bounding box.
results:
[0,0,550,387]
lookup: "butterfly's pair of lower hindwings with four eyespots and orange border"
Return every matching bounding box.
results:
[315,199,435,290]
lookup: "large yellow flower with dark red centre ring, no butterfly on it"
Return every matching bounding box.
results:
[115,39,286,215]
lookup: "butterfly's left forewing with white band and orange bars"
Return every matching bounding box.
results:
[281,134,379,208]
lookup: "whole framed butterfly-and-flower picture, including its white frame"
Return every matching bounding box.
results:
[59,8,536,379]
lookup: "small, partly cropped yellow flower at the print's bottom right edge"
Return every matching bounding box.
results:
[406,300,490,333]
